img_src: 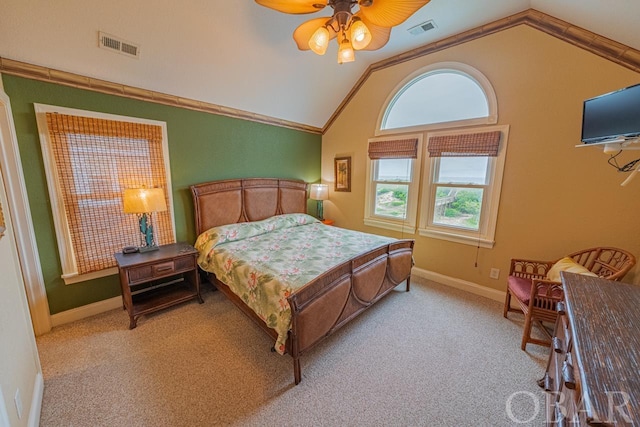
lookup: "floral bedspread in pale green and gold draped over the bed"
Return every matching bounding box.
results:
[195,214,395,354]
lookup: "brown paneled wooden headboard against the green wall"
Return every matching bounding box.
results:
[191,178,307,236]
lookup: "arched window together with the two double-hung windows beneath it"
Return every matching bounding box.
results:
[365,62,509,247]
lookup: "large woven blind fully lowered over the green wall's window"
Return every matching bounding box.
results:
[46,113,174,274]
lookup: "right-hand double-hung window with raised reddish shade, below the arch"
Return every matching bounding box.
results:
[419,126,508,247]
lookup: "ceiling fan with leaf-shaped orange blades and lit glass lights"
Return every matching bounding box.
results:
[255,0,430,64]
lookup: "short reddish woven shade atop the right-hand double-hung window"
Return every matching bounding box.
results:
[427,131,501,157]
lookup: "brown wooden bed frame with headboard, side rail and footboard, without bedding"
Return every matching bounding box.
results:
[191,178,414,384]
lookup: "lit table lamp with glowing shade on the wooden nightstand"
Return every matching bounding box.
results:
[122,188,167,252]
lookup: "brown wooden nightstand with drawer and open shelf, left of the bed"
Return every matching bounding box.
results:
[114,243,204,329]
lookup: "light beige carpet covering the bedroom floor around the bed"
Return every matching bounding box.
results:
[37,278,548,427]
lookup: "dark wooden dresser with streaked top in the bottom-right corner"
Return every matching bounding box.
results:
[541,273,640,426]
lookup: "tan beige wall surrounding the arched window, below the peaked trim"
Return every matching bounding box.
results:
[322,25,640,291]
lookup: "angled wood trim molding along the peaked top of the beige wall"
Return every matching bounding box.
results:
[322,9,640,134]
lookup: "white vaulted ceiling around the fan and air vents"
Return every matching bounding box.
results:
[0,0,640,128]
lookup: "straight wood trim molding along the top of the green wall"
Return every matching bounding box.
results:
[0,57,322,134]
